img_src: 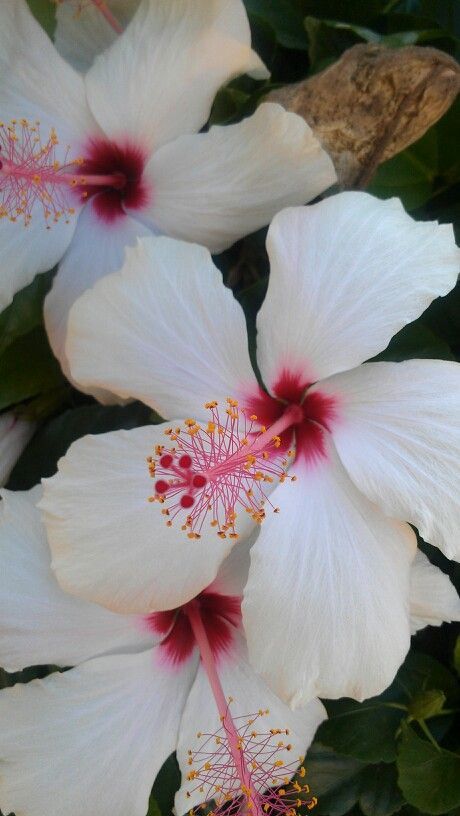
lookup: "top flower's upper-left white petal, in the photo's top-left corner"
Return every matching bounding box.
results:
[0,0,97,149]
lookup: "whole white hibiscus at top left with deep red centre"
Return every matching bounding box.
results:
[0,0,335,380]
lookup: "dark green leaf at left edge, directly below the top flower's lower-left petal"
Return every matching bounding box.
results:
[0,272,53,355]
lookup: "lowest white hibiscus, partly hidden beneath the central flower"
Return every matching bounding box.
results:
[0,488,326,816]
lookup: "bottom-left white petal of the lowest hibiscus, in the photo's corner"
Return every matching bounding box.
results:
[0,651,196,816]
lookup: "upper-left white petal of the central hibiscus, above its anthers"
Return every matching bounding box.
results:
[66,238,257,417]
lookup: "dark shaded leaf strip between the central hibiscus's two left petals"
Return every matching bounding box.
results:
[8,402,156,490]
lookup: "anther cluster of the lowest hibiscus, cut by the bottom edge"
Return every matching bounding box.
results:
[186,698,317,816]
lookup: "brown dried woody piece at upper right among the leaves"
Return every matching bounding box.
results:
[266,45,460,189]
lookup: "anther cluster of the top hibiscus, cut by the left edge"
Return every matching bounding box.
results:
[0,119,83,229]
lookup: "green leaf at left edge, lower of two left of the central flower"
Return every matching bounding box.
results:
[0,326,65,410]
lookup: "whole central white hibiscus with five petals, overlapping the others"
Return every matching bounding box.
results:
[42,192,460,706]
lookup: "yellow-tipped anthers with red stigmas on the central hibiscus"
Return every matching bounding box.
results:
[147,397,296,539]
